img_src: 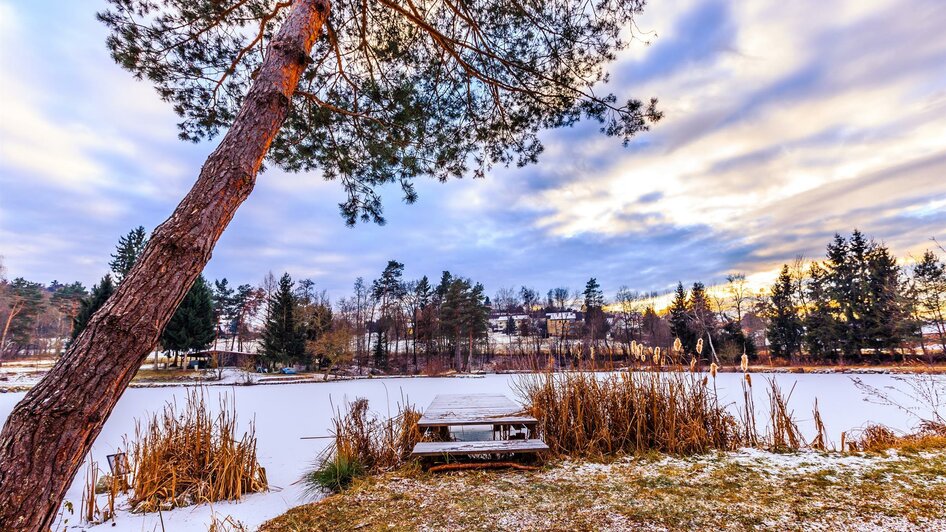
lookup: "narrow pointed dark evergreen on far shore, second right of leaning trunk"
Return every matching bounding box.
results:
[260,273,305,367]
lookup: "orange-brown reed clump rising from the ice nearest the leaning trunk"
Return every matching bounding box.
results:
[128,390,268,512]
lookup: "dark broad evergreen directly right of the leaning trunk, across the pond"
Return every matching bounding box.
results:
[161,275,216,357]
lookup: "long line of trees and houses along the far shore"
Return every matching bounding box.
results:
[0,227,946,372]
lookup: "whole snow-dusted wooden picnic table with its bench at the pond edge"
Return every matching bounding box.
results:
[412,394,549,458]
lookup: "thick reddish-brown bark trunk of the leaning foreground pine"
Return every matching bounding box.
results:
[0,0,329,532]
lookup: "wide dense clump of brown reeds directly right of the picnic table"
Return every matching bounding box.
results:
[517,372,741,456]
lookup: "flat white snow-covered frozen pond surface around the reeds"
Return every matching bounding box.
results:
[0,373,946,532]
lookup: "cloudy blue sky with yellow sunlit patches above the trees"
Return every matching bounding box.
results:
[0,0,946,297]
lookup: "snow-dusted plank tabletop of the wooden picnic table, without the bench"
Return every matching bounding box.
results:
[417,394,538,427]
